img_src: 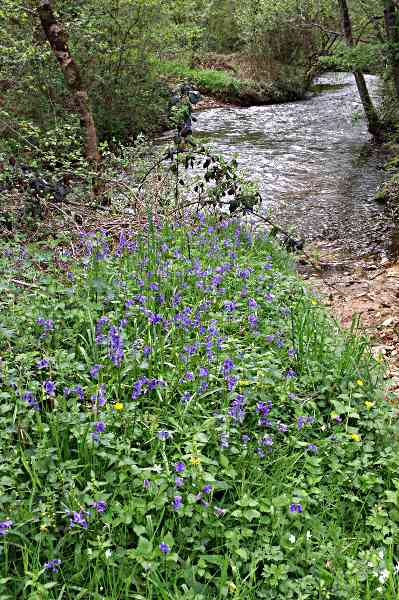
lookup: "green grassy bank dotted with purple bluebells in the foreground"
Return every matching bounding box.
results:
[0,218,399,600]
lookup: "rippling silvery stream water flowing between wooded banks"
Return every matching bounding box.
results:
[195,73,390,256]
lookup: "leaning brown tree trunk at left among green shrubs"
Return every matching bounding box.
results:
[38,0,99,161]
